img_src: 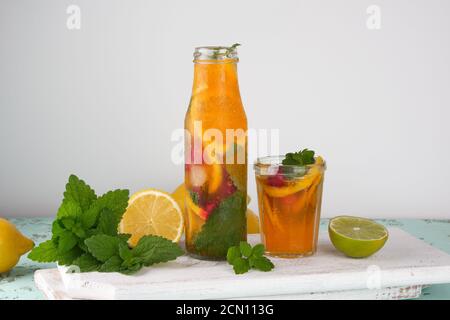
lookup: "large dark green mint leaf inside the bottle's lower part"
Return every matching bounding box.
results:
[194,191,247,258]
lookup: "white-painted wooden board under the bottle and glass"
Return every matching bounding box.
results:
[35,228,450,299]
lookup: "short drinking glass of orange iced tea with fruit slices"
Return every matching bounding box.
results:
[254,156,325,258]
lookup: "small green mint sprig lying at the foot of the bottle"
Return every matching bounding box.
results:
[227,241,275,274]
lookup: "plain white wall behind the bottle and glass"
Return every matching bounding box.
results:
[0,0,450,218]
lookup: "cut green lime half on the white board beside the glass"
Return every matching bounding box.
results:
[328,216,388,258]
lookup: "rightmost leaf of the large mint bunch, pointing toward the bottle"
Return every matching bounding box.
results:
[132,236,184,267]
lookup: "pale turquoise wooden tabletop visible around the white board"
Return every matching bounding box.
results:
[0,218,450,300]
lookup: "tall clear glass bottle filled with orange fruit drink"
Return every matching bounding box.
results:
[185,45,247,260]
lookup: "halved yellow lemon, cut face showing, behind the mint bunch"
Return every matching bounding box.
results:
[119,189,184,247]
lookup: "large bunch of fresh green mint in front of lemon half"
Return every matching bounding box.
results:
[28,175,183,274]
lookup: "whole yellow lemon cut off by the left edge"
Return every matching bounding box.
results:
[0,218,34,273]
